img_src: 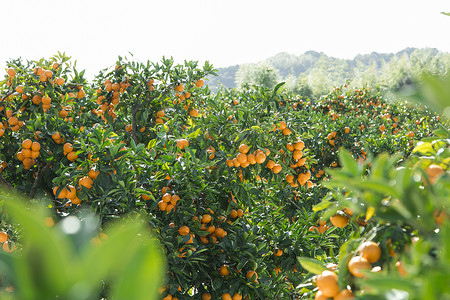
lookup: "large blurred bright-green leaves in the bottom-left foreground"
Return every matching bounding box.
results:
[0,190,165,299]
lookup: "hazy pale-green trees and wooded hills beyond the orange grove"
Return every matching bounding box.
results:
[209,48,450,98]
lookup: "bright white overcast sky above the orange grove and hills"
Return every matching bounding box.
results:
[0,0,450,75]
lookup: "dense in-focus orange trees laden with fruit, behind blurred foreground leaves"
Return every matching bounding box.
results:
[0,54,439,299]
